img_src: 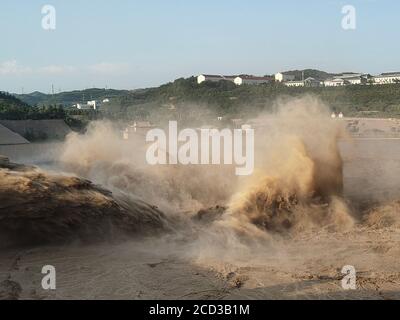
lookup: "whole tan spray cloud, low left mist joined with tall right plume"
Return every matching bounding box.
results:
[57,96,353,241]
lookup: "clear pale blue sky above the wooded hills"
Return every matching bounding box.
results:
[0,0,400,93]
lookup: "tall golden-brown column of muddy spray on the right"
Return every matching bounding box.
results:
[223,97,353,232]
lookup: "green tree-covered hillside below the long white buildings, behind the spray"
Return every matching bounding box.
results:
[101,77,400,120]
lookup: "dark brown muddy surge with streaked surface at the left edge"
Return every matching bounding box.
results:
[0,159,166,247]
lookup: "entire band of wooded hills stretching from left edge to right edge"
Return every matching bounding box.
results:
[0,74,400,123]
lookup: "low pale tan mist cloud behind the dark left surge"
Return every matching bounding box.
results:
[60,122,236,217]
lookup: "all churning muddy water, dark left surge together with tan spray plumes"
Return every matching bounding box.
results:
[0,97,360,249]
